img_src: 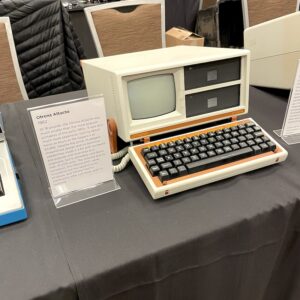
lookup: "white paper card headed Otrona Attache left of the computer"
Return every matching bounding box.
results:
[30,97,113,198]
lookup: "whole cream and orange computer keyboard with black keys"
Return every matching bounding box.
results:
[129,119,287,199]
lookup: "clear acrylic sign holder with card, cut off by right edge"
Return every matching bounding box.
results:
[274,61,300,145]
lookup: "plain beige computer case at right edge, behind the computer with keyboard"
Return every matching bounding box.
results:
[244,11,300,89]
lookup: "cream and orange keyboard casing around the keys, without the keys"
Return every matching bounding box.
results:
[129,119,288,199]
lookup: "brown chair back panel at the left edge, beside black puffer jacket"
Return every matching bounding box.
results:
[0,23,23,103]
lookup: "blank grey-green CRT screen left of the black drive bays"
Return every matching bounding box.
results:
[127,74,176,120]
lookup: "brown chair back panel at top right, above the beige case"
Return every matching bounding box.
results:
[247,0,297,26]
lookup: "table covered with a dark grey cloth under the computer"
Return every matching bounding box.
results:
[0,88,300,300]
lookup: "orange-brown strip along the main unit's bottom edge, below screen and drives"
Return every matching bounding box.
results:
[130,109,245,140]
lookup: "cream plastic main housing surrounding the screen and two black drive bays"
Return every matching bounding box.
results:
[82,46,249,142]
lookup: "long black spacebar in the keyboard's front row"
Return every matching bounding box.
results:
[186,147,254,173]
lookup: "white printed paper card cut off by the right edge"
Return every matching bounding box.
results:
[281,61,300,137]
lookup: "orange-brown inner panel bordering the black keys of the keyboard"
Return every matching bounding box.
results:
[134,119,282,187]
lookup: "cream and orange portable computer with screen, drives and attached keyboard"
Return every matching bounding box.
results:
[82,46,287,199]
